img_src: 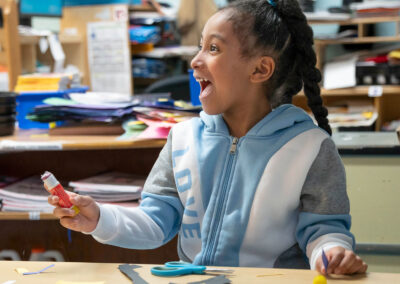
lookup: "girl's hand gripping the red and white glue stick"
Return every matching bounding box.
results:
[48,192,100,232]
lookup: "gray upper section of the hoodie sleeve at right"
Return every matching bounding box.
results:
[300,138,350,214]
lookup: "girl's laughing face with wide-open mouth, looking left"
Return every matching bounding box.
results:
[191,11,260,114]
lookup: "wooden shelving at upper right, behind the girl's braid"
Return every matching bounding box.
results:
[306,16,400,131]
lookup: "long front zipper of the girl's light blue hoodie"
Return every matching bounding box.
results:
[203,137,239,265]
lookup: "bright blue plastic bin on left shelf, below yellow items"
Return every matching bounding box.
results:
[16,87,88,129]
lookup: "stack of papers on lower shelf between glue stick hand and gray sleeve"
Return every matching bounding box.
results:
[68,172,145,206]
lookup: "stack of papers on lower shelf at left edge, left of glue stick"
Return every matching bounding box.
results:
[0,175,54,213]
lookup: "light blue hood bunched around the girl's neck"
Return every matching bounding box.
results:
[200,104,317,137]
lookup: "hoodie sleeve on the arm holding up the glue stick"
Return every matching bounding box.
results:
[90,134,183,249]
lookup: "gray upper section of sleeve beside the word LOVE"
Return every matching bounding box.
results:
[143,132,178,197]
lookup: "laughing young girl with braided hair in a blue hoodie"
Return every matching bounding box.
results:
[49,0,367,274]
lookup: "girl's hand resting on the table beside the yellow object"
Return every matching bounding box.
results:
[315,246,368,274]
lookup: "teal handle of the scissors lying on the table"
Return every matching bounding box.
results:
[150,261,206,276]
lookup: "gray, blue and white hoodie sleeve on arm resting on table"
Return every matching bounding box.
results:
[296,138,355,269]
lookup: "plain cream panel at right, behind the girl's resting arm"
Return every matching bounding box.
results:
[342,155,400,273]
